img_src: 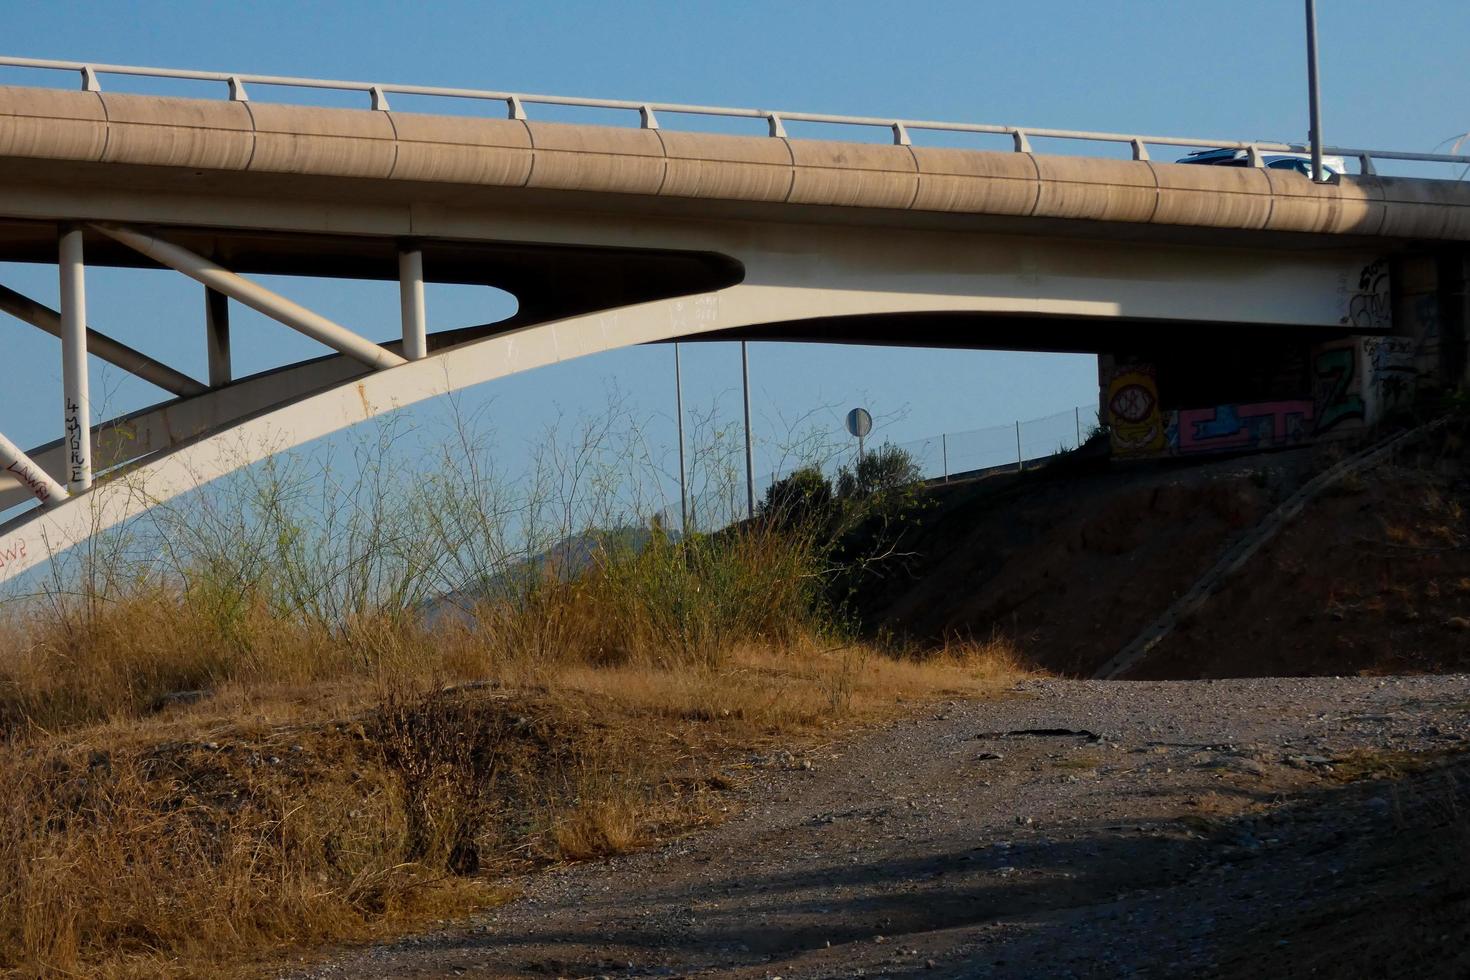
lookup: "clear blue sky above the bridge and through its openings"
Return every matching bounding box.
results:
[0,0,1470,514]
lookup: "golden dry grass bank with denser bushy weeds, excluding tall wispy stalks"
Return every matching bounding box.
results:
[0,531,1019,976]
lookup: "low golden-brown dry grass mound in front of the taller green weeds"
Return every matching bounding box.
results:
[0,645,1014,976]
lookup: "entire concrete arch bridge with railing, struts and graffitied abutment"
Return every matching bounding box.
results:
[0,57,1470,582]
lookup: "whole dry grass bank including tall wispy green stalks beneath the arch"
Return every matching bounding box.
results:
[0,426,1020,977]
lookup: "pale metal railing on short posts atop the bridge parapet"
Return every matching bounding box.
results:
[0,56,1470,175]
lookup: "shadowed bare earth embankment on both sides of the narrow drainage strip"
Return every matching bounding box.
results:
[861,426,1470,677]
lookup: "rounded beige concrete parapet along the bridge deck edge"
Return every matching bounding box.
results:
[0,87,1470,241]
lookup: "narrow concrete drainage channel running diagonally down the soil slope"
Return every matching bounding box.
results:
[1092,419,1448,680]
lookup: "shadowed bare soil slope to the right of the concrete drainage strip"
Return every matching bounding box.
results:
[1130,444,1470,677]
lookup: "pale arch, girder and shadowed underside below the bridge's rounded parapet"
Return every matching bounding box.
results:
[0,155,1422,582]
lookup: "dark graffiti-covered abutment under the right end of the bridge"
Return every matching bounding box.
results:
[1098,248,1470,457]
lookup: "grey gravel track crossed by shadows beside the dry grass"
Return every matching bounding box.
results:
[293,674,1470,980]
